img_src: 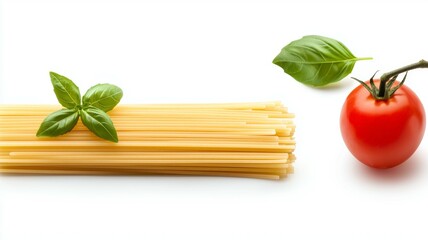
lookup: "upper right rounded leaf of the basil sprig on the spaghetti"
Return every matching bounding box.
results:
[83,84,123,112]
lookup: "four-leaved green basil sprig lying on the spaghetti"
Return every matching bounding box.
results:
[37,72,123,142]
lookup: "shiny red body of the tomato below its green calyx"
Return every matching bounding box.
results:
[340,80,426,168]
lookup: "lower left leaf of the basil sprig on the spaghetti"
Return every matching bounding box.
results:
[36,109,79,137]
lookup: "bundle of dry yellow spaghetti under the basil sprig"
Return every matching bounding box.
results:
[0,102,295,179]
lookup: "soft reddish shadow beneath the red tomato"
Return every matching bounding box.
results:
[352,153,424,182]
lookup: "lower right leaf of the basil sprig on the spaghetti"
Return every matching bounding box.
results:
[80,107,119,142]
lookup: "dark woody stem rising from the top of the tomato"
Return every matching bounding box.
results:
[375,59,428,100]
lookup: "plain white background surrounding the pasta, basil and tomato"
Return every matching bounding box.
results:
[0,0,428,240]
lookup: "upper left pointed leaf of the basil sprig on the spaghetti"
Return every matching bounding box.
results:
[49,72,80,109]
